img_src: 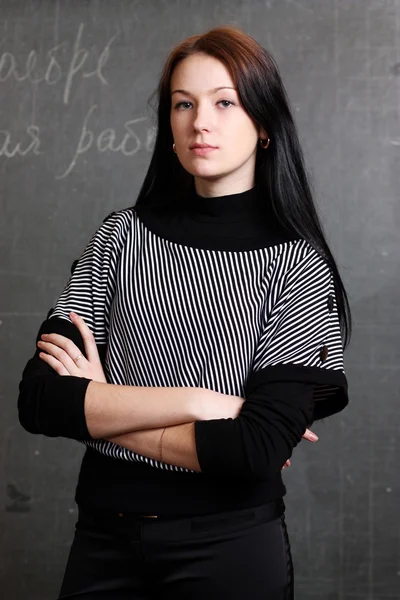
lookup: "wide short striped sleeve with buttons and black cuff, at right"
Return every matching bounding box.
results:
[247,246,348,420]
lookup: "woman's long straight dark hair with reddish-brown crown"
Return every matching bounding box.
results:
[136,27,351,347]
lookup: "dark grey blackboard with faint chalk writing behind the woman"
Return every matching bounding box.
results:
[0,0,400,600]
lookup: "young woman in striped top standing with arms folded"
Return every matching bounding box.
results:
[19,27,350,600]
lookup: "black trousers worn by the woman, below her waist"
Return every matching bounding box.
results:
[59,500,293,600]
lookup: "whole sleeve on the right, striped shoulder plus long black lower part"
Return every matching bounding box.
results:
[195,241,348,480]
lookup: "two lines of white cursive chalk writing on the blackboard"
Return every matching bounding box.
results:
[0,23,156,179]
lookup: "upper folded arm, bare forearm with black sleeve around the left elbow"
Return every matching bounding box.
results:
[18,317,236,441]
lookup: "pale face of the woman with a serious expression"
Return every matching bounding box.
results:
[171,54,259,189]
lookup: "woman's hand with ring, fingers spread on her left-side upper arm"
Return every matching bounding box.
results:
[38,312,107,383]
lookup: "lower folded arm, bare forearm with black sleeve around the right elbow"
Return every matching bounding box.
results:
[109,382,314,480]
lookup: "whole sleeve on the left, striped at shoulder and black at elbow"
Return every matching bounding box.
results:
[18,211,130,441]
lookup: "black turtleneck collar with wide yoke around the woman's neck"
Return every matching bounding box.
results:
[135,185,295,251]
